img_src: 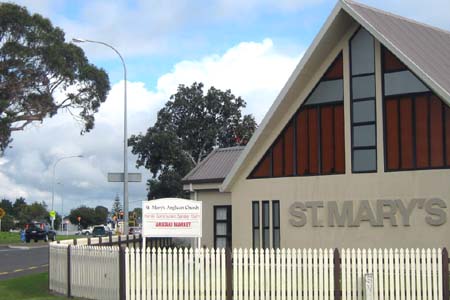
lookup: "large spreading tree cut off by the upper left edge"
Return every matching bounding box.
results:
[0,3,110,154]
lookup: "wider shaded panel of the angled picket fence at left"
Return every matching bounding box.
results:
[70,246,120,300]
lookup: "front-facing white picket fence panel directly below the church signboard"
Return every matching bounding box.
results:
[125,248,226,300]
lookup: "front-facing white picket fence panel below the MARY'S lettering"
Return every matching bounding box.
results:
[341,249,442,300]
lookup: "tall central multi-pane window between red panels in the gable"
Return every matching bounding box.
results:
[350,28,377,173]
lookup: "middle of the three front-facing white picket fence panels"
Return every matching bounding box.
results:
[233,249,334,300]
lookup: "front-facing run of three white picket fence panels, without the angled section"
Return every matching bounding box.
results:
[125,248,443,300]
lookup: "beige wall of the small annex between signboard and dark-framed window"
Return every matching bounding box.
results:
[191,189,231,248]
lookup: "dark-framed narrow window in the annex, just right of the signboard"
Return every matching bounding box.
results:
[214,205,231,248]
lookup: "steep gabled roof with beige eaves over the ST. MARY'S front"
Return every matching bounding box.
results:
[221,0,450,191]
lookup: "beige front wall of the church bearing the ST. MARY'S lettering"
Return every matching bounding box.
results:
[231,27,450,248]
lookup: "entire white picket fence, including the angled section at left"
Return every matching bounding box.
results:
[49,244,448,300]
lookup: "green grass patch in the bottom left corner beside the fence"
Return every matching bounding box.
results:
[0,273,67,300]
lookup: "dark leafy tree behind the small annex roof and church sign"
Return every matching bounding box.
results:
[129,83,256,199]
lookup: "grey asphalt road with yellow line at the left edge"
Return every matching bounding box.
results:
[0,243,48,280]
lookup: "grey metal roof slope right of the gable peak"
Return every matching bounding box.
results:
[344,0,450,99]
